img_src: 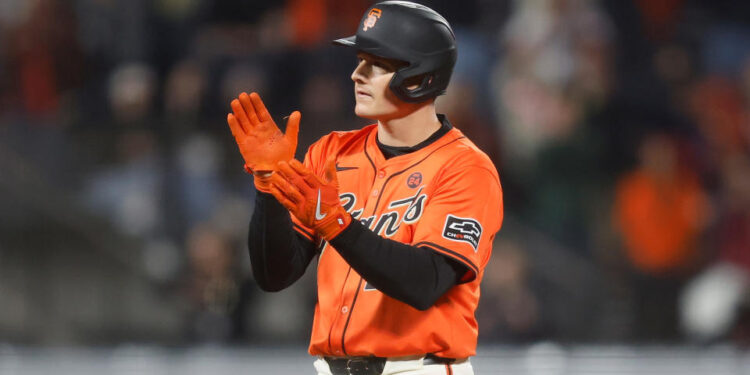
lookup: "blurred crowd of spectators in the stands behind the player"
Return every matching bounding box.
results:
[0,0,750,343]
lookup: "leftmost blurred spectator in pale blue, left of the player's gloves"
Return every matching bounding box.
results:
[83,63,164,237]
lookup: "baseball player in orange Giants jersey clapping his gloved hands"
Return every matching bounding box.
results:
[227,1,503,375]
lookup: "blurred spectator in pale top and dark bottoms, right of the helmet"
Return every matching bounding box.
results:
[493,1,614,235]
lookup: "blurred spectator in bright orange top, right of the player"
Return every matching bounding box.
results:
[613,133,711,340]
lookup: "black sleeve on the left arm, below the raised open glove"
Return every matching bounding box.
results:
[247,192,317,292]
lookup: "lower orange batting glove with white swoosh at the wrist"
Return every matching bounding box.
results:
[270,159,352,240]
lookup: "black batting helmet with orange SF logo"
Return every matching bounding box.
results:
[333,1,456,103]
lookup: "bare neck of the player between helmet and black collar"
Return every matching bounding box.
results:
[378,103,440,147]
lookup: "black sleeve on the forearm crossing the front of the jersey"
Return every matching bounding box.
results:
[330,220,467,310]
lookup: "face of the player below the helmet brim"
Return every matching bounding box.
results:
[352,52,409,120]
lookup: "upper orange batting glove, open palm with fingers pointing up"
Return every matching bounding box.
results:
[227,92,302,193]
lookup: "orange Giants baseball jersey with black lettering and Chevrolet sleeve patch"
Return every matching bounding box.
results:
[293,125,503,358]
